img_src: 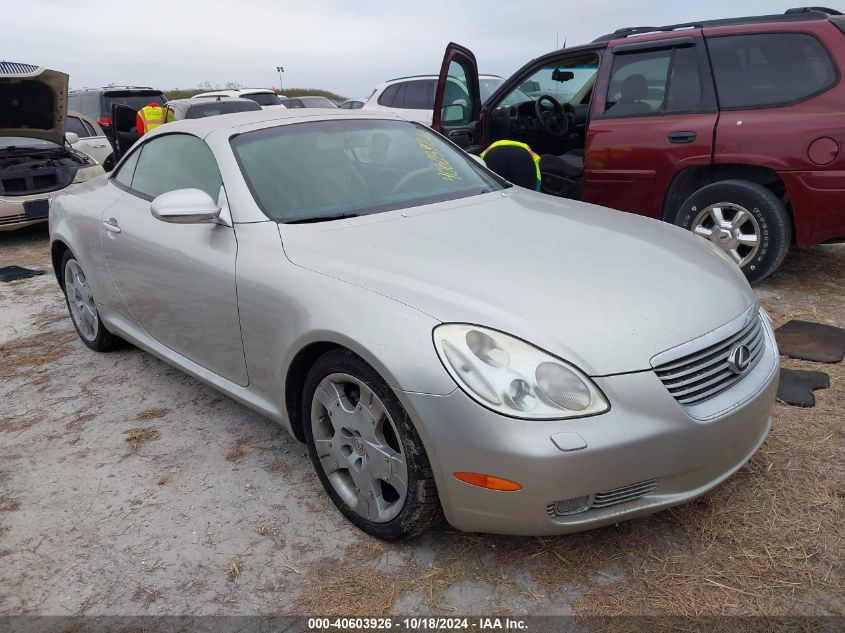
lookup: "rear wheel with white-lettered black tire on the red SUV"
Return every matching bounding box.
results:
[675,180,792,283]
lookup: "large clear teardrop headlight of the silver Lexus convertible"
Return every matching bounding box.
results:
[434,323,610,420]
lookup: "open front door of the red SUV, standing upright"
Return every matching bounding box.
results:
[431,42,483,154]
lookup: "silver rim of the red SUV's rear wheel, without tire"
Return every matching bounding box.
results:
[692,202,761,267]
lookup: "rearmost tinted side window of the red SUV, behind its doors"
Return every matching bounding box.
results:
[707,33,838,109]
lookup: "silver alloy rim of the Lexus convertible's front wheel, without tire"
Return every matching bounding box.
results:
[311,373,408,523]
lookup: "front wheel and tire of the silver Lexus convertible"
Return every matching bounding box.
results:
[302,350,443,541]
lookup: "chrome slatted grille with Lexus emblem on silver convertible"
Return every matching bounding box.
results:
[654,314,765,406]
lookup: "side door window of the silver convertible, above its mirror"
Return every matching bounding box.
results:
[132,134,223,200]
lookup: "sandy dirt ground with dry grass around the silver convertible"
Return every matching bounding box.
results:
[0,229,845,616]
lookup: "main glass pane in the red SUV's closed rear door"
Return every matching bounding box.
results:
[605,49,673,117]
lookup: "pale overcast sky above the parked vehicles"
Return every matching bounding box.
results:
[0,0,812,97]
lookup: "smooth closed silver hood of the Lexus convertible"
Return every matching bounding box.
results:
[279,189,755,376]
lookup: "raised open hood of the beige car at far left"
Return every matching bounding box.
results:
[0,62,68,145]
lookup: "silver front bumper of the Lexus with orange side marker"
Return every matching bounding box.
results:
[398,320,779,536]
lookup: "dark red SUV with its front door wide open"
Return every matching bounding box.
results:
[433,7,845,282]
